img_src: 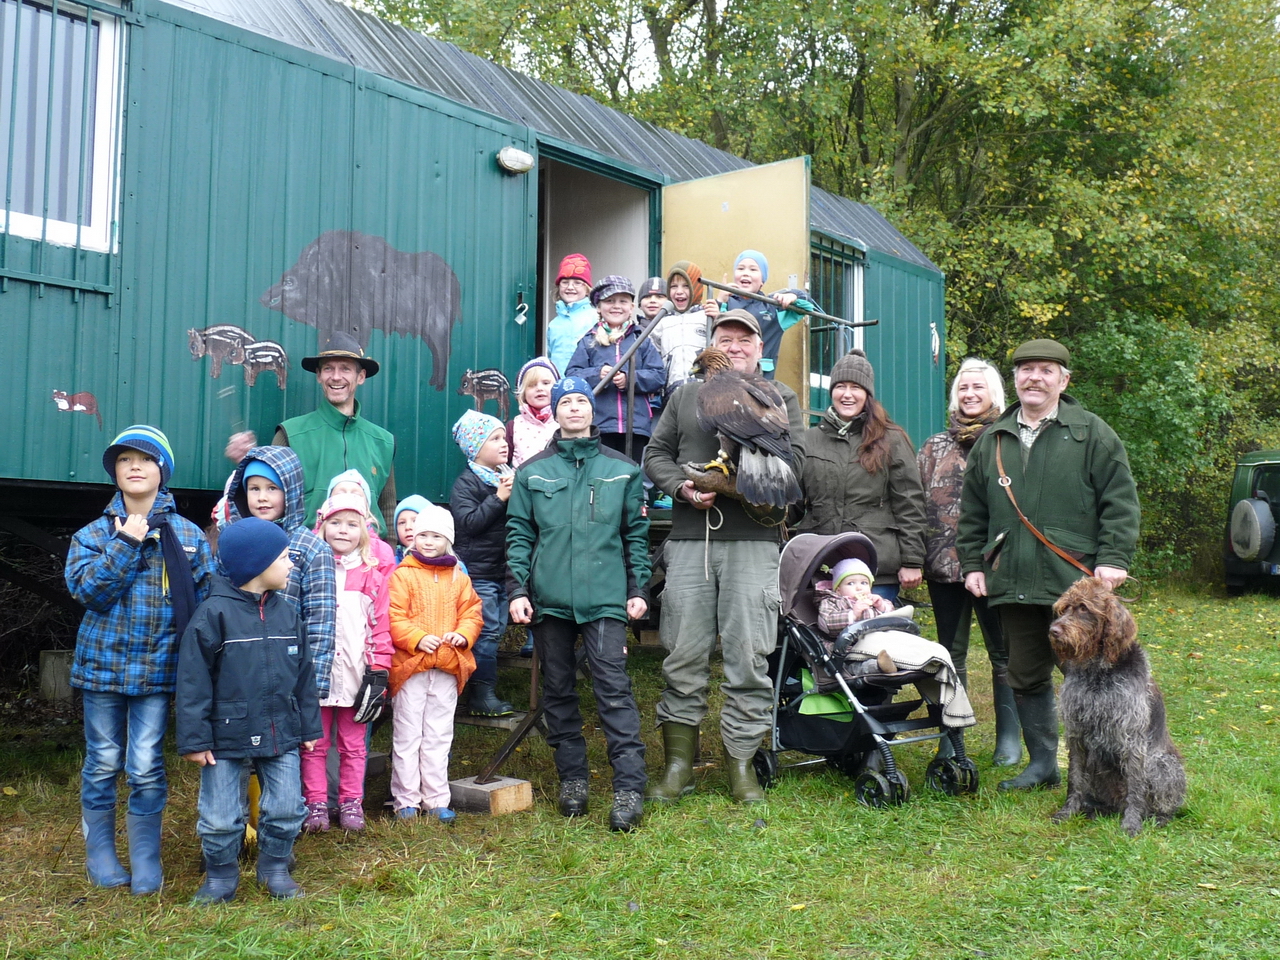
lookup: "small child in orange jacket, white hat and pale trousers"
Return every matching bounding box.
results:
[388,504,484,823]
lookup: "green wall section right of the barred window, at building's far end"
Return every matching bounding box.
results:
[864,250,946,449]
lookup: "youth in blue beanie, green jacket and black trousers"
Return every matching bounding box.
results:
[507,376,649,831]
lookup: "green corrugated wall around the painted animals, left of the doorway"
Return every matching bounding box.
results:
[0,5,536,499]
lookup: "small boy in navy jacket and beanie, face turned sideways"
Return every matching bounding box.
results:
[175,517,321,904]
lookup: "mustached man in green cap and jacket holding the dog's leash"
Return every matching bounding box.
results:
[956,339,1139,790]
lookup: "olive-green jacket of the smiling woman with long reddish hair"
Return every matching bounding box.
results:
[796,417,924,584]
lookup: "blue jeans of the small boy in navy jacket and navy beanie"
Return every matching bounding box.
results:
[196,750,307,865]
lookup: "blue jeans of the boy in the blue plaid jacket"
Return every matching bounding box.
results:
[81,690,169,817]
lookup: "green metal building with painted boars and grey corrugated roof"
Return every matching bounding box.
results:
[0,0,945,516]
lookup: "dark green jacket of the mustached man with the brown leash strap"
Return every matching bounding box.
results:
[956,394,1140,604]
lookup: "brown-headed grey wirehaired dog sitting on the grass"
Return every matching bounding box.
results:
[1048,577,1187,836]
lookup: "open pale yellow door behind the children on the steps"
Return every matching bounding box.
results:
[662,156,809,406]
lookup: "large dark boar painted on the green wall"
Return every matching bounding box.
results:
[260,230,462,390]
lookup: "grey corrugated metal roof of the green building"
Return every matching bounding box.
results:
[164,0,941,273]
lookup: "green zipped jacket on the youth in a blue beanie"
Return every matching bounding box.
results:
[507,428,649,623]
